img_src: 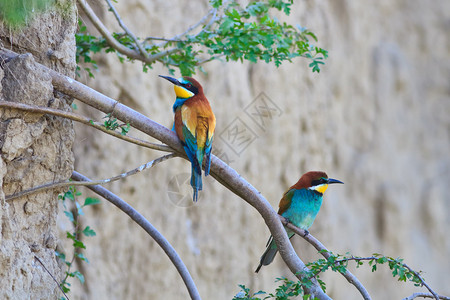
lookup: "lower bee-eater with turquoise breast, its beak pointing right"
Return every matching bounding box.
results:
[255,171,343,273]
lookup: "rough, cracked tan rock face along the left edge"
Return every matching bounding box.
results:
[0,1,76,299]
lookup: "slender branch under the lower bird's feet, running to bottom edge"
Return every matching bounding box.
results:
[279,216,371,300]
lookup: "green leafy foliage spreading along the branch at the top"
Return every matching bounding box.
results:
[76,0,328,76]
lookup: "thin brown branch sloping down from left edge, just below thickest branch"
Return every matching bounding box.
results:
[0,100,173,152]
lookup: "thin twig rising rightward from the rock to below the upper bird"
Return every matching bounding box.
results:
[5,153,176,201]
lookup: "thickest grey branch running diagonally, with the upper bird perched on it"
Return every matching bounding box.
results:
[0,49,331,300]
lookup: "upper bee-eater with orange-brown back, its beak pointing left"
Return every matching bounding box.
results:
[159,75,216,202]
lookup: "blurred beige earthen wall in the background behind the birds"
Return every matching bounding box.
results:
[69,0,450,299]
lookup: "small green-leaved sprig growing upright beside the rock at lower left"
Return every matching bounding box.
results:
[55,186,100,300]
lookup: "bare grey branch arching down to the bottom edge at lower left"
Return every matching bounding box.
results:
[72,172,201,300]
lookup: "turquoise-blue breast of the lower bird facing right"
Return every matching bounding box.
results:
[281,189,323,230]
